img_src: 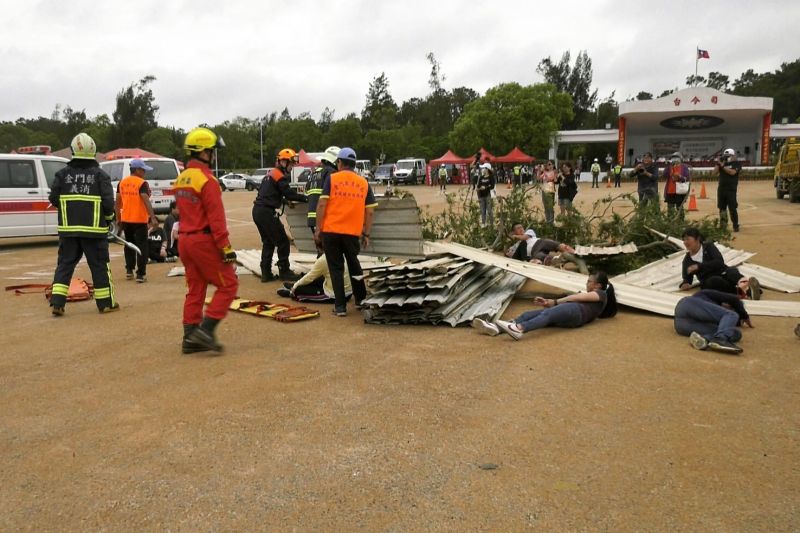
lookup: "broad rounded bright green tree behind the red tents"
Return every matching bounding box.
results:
[450,83,574,154]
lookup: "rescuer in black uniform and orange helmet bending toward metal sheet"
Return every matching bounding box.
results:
[253,148,308,283]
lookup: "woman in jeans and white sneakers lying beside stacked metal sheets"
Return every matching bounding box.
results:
[472,272,617,341]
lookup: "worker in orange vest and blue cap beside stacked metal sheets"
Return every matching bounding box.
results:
[314,148,378,316]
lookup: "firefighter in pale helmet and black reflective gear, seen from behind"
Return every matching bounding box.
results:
[48,133,119,316]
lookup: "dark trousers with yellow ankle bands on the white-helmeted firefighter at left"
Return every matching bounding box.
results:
[50,234,117,310]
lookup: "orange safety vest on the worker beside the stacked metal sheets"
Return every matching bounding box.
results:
[320,170,369,236]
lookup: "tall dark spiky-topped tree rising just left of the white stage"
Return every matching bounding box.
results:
[536,50,597,129]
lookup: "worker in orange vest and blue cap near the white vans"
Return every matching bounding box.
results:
[116,159,158,283]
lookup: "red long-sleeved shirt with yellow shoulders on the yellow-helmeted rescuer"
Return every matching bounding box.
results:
[175,159,230,250]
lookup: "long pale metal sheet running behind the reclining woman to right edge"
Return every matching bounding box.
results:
[425,242,800,317]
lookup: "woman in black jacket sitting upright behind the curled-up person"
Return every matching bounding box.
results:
[680,227,762,300]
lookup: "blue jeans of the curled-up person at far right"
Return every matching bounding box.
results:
[675,296,742,342]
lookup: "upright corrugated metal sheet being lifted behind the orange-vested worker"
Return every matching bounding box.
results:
[284,197,425,258]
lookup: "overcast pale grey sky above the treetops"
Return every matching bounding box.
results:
[0,0,800,128]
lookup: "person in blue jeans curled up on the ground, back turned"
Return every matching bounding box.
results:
[675,289,753,355]
